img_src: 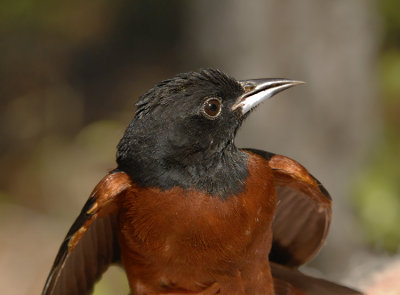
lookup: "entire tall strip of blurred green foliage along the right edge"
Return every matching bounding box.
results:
[355,0,400,252]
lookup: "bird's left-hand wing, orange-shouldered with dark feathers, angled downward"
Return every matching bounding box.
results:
[42,170,131,295]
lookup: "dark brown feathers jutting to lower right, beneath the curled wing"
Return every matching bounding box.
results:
[271,263,362,295]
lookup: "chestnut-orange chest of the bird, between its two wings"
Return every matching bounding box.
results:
[119,155,276,291]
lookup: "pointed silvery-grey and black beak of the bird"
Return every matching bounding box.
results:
[232,79,304,115]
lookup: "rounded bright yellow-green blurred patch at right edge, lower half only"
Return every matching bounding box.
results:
[356,142,400,252]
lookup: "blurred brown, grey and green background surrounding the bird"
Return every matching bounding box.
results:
[0,0,400,295]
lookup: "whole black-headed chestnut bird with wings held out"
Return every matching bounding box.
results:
[42,69,361,295]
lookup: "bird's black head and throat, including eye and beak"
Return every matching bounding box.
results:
[117,69,297,197]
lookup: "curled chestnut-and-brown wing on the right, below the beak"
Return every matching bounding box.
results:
[245,149,332,267]
